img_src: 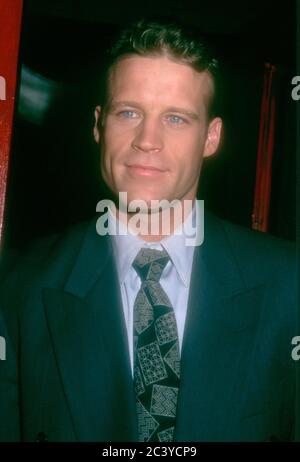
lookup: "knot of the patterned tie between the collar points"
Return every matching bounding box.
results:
[132,248,170,282]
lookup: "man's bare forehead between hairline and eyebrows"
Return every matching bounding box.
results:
[109,55,213,108]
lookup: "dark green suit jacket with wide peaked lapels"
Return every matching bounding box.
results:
[0,215,297,442]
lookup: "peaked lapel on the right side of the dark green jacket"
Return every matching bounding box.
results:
[176,215,265,441]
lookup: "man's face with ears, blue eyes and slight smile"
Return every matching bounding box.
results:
[94,55,222,205]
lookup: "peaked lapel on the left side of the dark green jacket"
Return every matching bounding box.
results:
[43,223,136,441]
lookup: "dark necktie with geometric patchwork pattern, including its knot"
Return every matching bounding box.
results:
[133,249,180,442]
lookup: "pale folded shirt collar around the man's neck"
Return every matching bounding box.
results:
[108,201,197,287]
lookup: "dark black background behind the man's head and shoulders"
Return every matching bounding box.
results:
[4,0,297,247]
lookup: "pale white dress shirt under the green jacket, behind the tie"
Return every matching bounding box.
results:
[108,206,199,375]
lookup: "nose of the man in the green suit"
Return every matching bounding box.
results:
[132,118,163,152]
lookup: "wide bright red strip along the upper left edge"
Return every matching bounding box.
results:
[0,0,23,247]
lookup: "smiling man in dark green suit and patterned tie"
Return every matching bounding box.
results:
[0,21,296,442]
